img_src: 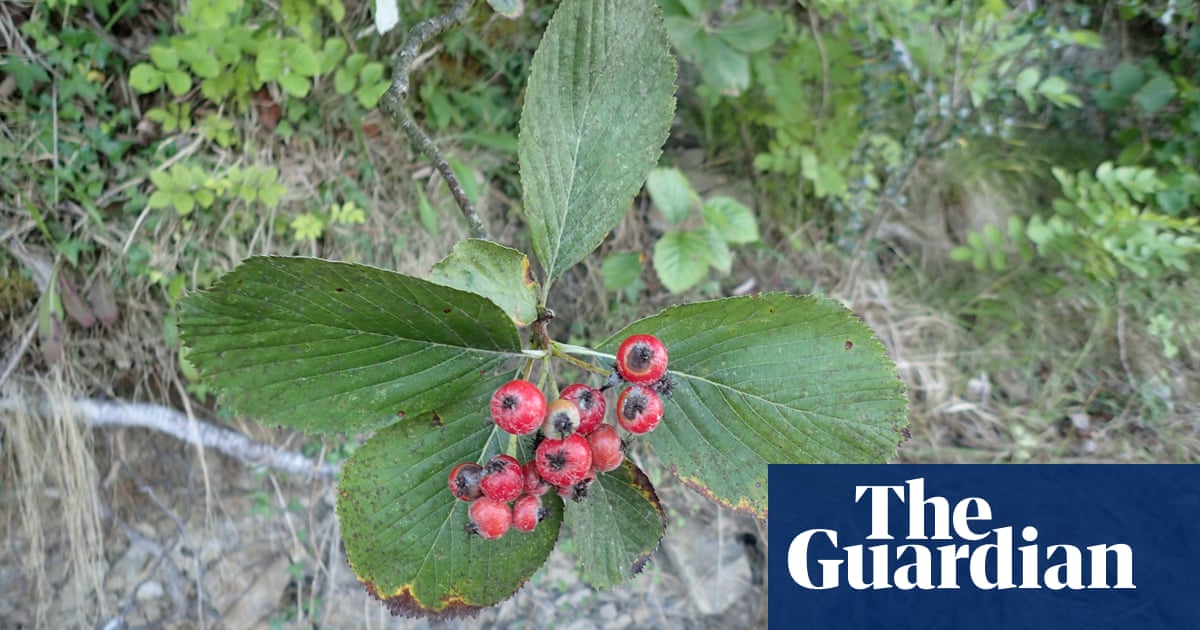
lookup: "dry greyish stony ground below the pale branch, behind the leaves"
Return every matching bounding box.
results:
[0,422,767,630]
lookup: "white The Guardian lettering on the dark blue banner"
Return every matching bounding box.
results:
[787,478,1136,590]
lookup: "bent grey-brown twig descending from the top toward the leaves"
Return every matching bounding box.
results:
[379,0,492,240]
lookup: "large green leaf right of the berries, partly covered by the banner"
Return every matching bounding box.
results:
[599,294,908,518]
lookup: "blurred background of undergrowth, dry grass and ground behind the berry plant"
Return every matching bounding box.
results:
[0,0,1200,626]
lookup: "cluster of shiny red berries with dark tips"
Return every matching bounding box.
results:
[450,335,671,540]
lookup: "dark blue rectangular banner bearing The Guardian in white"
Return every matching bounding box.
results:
[768,464,1200,630]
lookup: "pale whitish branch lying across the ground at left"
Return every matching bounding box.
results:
[0,398,340,479]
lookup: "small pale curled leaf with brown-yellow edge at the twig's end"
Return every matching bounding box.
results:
[430,239,538,326]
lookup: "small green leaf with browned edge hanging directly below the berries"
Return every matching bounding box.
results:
[561,458,666,588]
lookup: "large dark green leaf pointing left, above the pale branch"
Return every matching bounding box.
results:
[180,257,521,432]
